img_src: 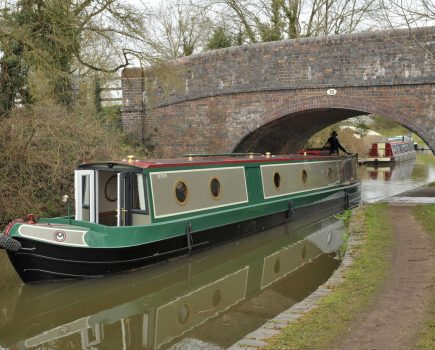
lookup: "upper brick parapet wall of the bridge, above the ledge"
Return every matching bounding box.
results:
[144,27,435,107]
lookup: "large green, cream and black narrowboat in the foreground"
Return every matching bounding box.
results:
[0,153,360,283]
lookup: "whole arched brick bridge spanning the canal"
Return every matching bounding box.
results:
[122,27,435,156]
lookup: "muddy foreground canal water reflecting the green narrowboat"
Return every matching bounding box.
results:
[0,218,343,349]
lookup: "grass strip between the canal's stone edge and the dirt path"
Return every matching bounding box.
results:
[267,204,393,350]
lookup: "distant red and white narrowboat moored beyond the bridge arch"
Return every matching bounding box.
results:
[366,136,417,163]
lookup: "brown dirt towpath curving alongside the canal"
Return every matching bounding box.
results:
[334,187,435,350]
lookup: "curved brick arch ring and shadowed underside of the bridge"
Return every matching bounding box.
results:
[232,91,426,153]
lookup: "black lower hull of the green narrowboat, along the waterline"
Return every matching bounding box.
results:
[8,187,360,283]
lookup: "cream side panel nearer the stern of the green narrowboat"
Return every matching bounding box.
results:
[260,160,339,198]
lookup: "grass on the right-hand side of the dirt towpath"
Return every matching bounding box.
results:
[414,204,435,349]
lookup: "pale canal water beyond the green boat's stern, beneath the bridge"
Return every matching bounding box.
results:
[358,151,435,203]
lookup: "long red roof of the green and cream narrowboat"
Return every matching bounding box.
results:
[77,153,344,169]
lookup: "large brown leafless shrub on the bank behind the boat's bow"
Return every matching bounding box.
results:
[0,103,131,227]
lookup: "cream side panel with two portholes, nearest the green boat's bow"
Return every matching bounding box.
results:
[150,167,248,218]
